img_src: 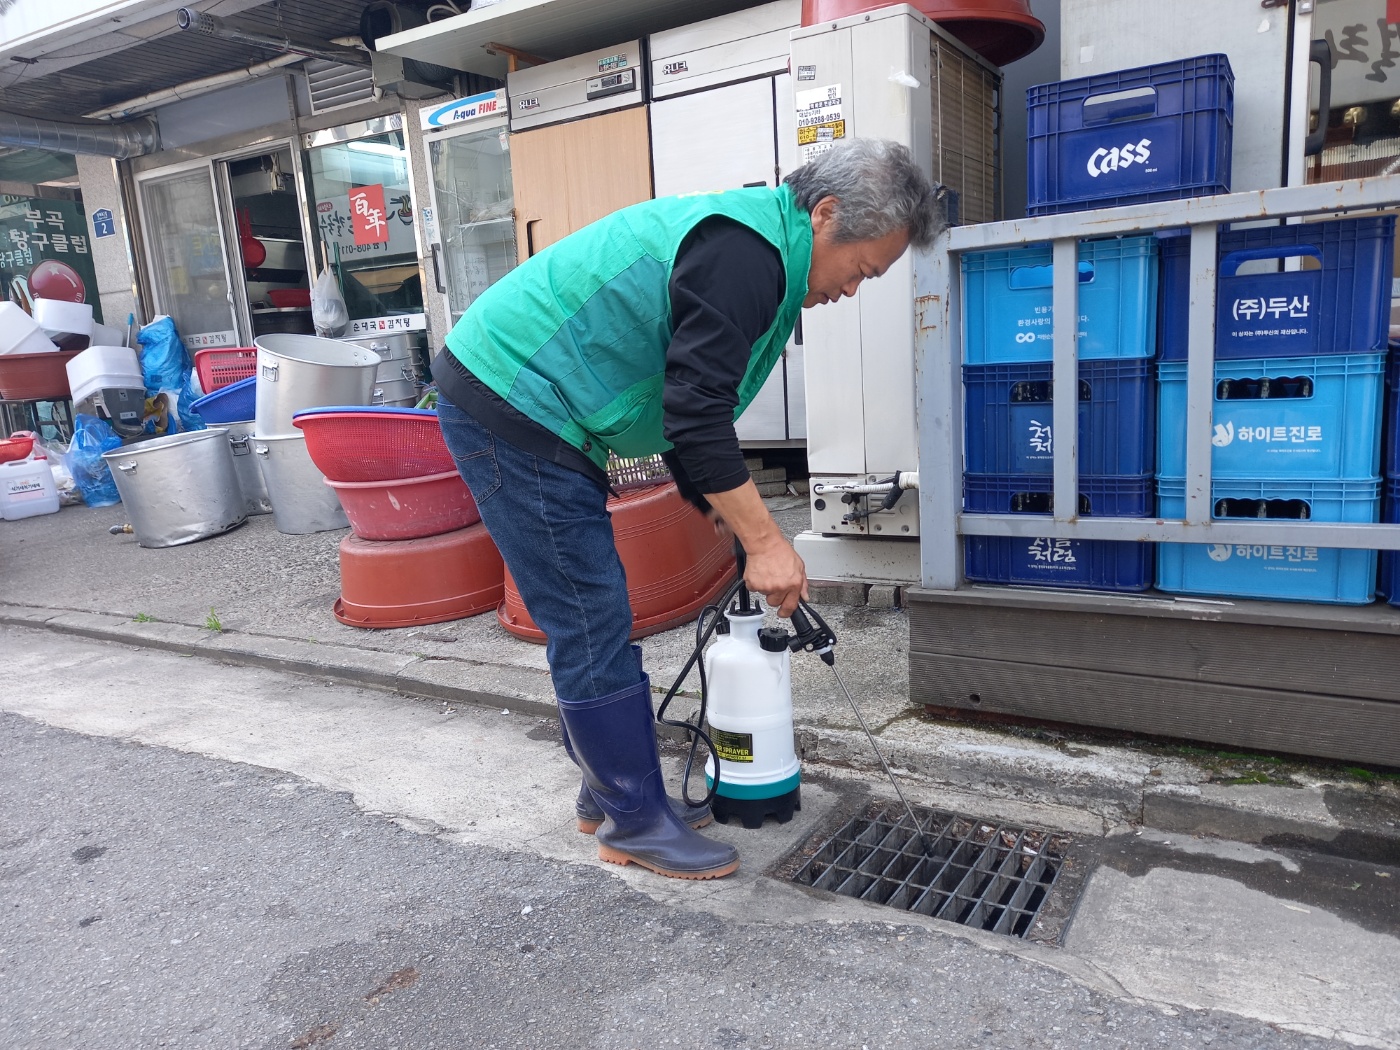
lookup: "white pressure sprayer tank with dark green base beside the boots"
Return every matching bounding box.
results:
[704,609,802,827]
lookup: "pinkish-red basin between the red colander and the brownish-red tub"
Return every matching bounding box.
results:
[326,470,482,539]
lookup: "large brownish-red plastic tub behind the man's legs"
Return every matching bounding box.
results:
[496,483,735,641]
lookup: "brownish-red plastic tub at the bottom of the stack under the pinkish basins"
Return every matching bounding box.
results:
[335,525,504,627]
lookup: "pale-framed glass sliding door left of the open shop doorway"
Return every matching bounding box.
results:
[140,167,239,351]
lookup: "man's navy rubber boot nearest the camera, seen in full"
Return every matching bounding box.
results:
[559,675,739,879]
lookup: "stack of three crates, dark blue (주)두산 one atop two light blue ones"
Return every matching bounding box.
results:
[1156,216,1394,605]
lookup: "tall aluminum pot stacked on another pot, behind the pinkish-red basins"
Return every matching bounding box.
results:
[253,335,379,436]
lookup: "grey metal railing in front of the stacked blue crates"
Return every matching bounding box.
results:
[914,175,1400,591]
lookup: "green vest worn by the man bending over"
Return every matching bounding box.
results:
[447,186,812,468]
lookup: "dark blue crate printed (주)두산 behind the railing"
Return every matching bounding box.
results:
[1159,216,1396,361]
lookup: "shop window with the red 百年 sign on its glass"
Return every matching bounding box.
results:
[301,130,424,336]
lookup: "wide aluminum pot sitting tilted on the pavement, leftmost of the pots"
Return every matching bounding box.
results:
[102,427,248,547]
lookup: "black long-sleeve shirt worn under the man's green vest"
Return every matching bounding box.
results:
[433,216,787,505]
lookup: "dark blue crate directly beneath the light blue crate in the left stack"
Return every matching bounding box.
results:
[963,357,1156,475]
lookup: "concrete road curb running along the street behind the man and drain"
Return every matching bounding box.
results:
[0,603,1400,864]
